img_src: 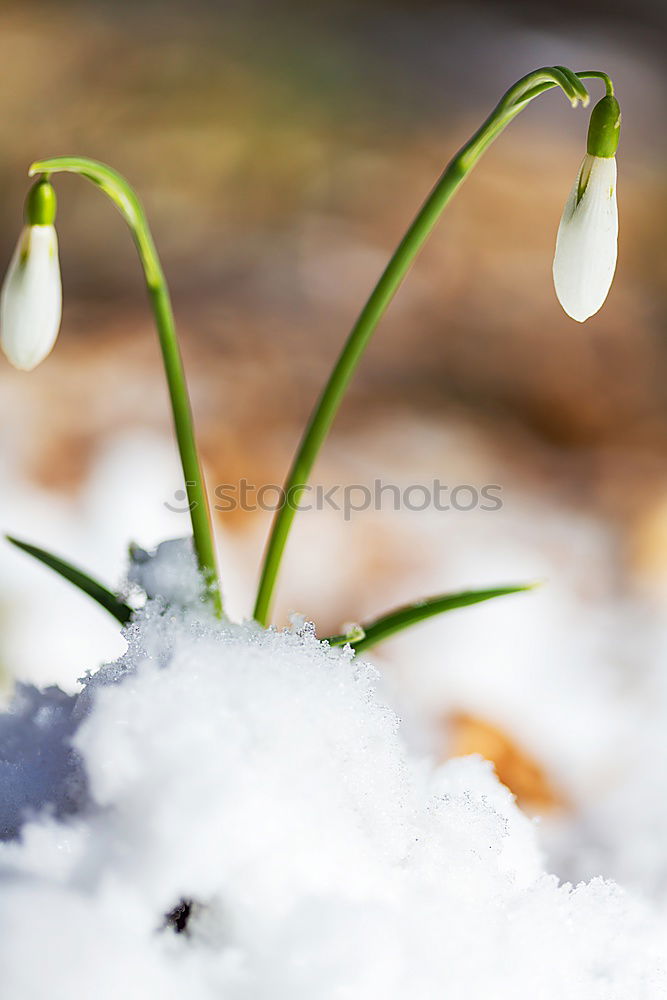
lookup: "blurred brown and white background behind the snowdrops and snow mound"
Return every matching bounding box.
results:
[0,0,667,892]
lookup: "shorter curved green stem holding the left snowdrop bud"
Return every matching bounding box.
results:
[30,156,222,614]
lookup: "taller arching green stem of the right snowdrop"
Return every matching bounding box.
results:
[255,66,609,625]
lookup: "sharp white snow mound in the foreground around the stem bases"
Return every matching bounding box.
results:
[0,546,667,1000]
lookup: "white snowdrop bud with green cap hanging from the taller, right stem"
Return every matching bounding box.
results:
[553,94,621,323]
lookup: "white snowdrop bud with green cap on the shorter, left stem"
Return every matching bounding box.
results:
[0,180,62,371]
